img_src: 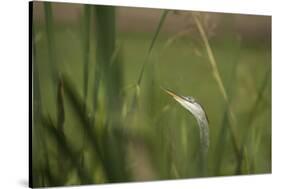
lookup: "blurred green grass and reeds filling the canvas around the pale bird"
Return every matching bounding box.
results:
[31,2,271,187]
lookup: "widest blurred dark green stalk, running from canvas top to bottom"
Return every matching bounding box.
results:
[93,6,129,182]
